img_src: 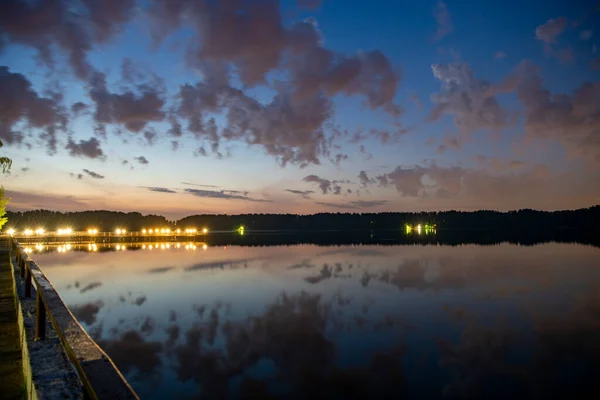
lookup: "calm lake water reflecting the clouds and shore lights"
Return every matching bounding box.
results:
[32,239,600,399]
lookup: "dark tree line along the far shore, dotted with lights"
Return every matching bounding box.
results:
[4,206,600,232]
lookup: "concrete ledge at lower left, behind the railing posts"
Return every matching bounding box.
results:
[10,255,84,400]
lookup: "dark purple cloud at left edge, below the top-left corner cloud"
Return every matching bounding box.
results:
[0,67,68,150]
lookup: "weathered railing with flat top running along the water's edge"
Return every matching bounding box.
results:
[10,238,138,399]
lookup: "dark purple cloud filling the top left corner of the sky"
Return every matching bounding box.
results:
[0,0,136,79]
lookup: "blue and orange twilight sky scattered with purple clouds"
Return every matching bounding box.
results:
[0,0,600,218]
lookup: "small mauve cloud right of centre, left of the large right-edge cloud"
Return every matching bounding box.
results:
[429,63,507,145]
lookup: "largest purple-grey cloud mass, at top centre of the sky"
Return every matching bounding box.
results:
[150,0,401,166]
